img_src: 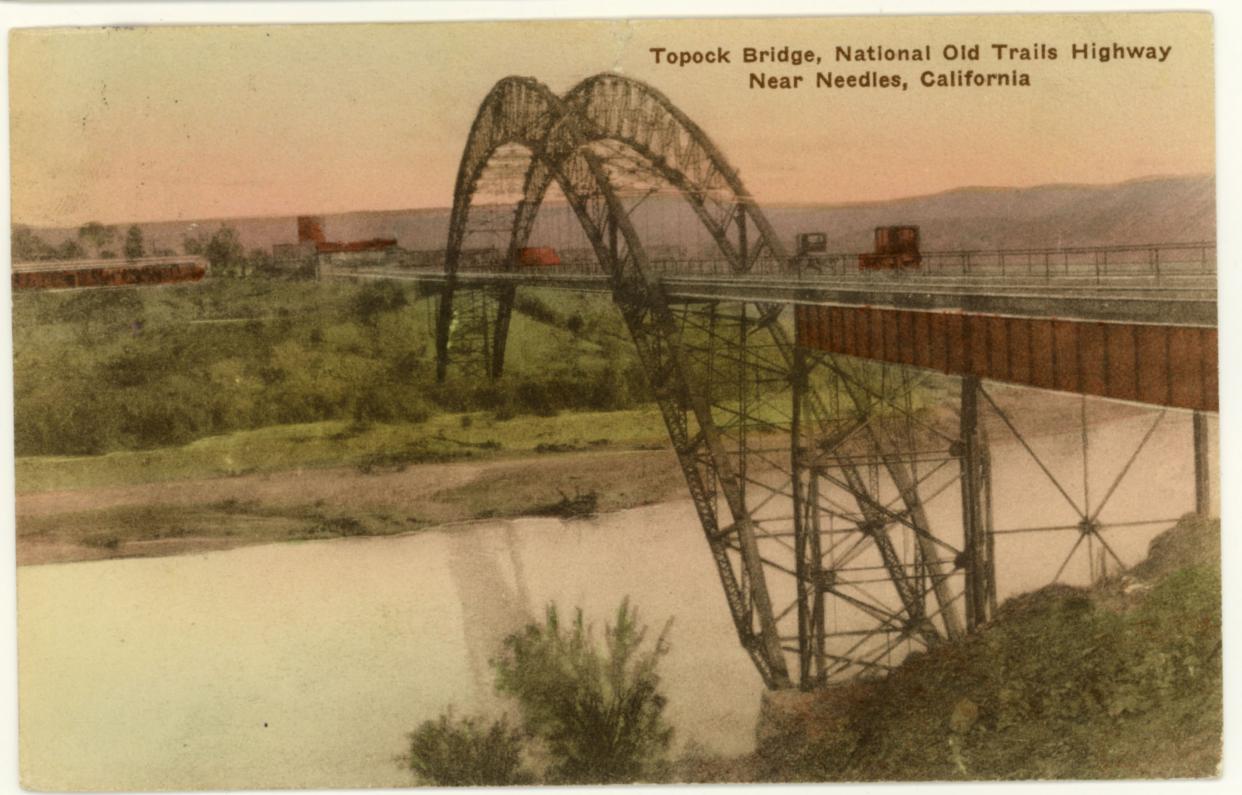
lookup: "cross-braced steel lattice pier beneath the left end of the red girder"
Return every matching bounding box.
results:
[790,345,990,687]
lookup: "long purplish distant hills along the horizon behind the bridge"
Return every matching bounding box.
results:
[24,176,1216,255]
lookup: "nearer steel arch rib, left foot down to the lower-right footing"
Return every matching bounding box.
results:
[436,71,790,687]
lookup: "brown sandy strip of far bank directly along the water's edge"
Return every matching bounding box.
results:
[16,450,684,565]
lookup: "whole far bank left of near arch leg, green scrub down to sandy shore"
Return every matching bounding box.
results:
[14,275,678,561]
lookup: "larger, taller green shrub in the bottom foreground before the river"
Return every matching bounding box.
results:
[493,600,672,784]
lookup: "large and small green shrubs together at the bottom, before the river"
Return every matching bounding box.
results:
[409,600,672,785]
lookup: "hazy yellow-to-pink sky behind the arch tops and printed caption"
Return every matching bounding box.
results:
[10,14,1213,225]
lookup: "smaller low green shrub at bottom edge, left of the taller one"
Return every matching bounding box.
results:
[406,711,534,786]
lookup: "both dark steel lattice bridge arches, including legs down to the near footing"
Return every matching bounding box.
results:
[436,75,960,688]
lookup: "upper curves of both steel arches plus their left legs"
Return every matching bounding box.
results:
[437,73,787,379]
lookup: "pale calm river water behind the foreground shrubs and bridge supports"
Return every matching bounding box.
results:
[17,415,1217,790]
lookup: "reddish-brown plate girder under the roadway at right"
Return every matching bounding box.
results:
[794,306,1220,411]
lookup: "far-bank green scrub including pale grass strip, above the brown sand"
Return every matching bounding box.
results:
[14,267,924,499]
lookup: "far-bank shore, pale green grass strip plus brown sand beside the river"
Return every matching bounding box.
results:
[16,388,1167,565]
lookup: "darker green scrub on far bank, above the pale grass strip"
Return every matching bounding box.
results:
[14,275,648,456]
